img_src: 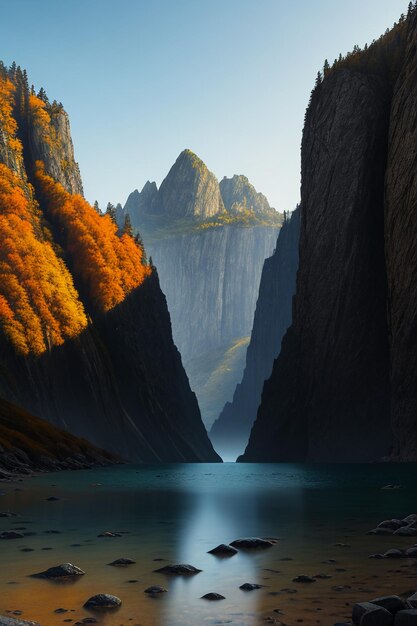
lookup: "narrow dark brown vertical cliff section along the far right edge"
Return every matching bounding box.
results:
[385,17,417,461]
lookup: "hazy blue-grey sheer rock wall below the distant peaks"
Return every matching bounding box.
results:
[148,225,277,425]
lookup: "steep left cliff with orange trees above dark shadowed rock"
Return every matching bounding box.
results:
[0,68,219,462]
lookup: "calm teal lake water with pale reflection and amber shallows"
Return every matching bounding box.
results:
[0,463,417,626]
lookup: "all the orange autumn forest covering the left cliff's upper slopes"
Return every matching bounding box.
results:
[0,67,152,355]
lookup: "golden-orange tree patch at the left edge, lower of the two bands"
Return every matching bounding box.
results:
[0,164,87,355]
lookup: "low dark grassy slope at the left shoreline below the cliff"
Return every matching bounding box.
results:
[0,398,118,479]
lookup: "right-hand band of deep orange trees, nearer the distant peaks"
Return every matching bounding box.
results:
[35,161,152,312]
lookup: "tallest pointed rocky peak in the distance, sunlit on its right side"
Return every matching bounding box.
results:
[158,150,224,220]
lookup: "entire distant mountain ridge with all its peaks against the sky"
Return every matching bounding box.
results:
[117,149,282,239]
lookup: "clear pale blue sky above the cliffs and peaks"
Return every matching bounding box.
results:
[0,0,408,210]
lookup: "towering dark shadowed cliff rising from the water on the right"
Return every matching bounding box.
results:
[240,11,417,461]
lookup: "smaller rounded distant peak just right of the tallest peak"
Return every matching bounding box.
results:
[220,174,274,213]
